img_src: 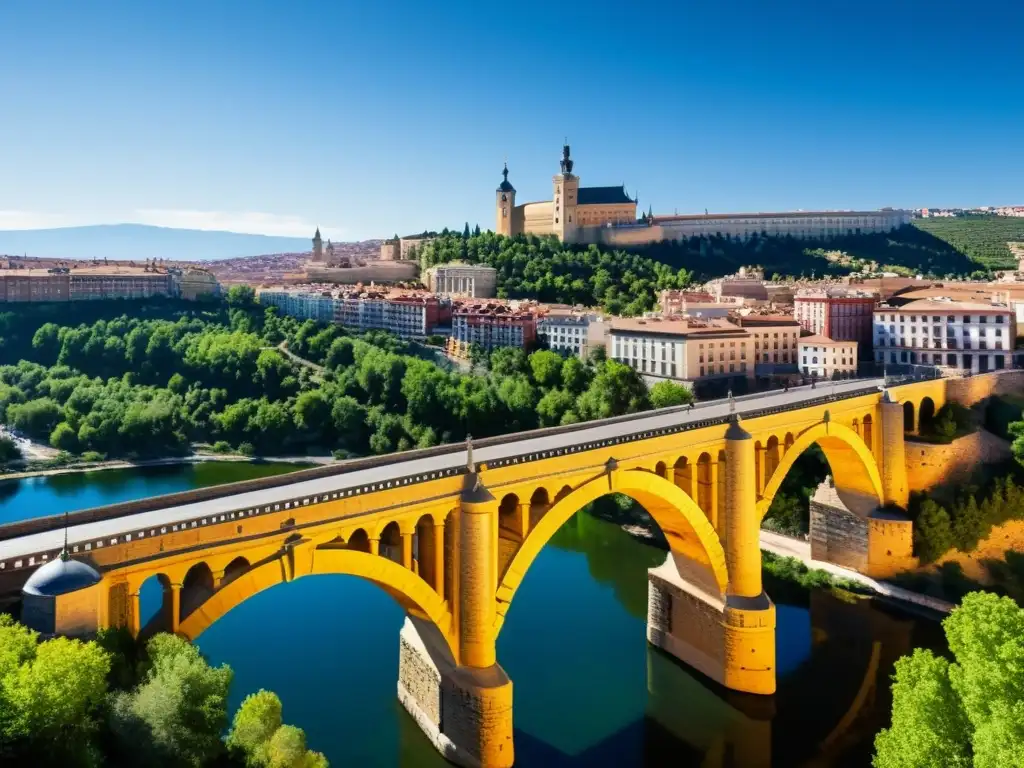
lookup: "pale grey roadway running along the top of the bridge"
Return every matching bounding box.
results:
[0,378,885,572]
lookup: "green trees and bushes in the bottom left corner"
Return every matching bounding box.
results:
[0,614,327,768]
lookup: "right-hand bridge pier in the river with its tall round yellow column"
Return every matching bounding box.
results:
[647,420,775,694]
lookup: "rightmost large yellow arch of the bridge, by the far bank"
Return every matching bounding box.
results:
[758,417,885,518]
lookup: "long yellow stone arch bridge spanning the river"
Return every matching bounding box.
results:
[0,381,958,766]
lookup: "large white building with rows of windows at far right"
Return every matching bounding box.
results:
[873,298,1017,373]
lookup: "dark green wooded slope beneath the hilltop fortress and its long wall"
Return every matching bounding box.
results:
[420,226,985,315]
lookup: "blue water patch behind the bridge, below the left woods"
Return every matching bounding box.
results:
[0,462,303,524]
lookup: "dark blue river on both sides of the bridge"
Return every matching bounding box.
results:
[0,464,944,768]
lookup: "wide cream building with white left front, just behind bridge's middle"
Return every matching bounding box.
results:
[608,317,754,382]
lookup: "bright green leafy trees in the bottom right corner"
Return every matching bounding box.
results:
[873,592,1024,768]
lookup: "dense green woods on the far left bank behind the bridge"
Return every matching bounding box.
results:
[0,296,671,457]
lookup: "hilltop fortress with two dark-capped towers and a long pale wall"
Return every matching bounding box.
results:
[495,144,910,246]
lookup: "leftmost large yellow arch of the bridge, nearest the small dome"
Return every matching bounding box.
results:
[178,548,456,654]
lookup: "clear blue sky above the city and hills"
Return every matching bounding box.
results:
[0,0,1024,239]
